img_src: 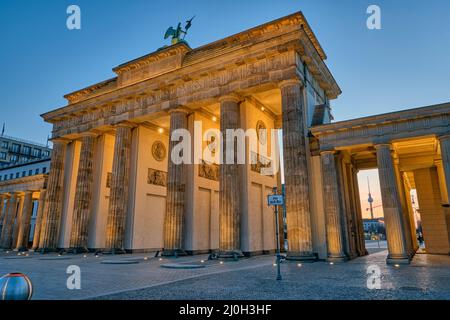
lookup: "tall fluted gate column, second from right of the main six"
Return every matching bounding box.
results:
[219,95,242,258]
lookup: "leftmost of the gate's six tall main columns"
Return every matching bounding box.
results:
[39,139,69,252]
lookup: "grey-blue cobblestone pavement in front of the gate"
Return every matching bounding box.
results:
[0,249,450,300]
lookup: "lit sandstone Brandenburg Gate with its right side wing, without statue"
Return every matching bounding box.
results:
[7,12,450,263]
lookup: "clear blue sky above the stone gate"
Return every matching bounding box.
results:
[0,0,450,142]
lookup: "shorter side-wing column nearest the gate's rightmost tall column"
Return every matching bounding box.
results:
[320,151,346,262]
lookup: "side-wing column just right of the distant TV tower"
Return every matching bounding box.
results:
[375,144,409,264]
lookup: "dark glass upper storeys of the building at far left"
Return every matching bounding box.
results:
[0,135,52,168]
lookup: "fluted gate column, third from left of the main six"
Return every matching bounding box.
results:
[105,122,134,254]
